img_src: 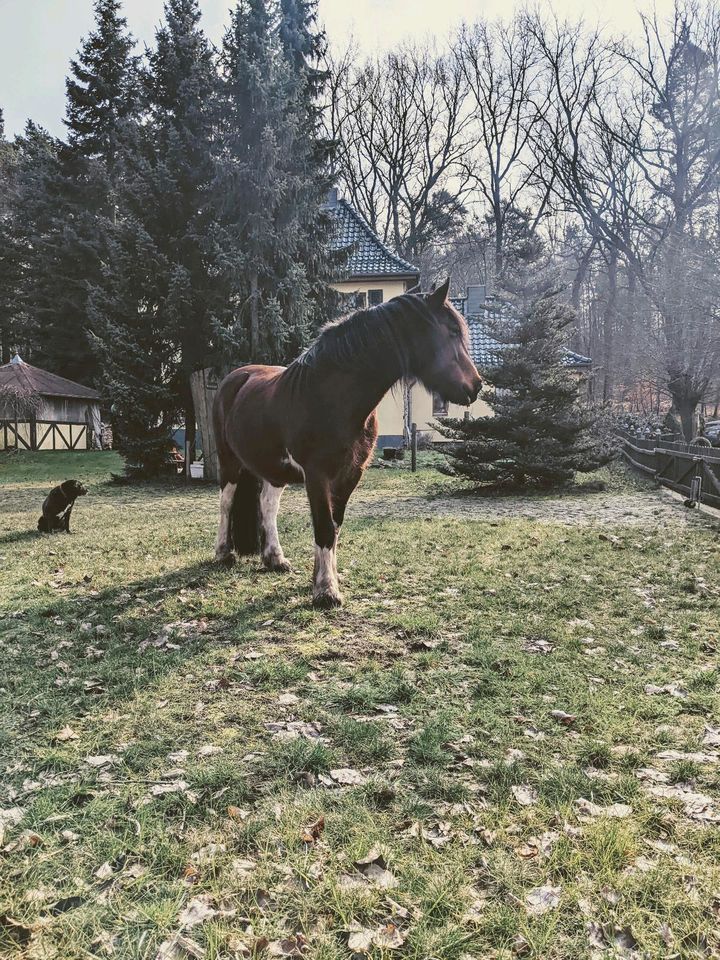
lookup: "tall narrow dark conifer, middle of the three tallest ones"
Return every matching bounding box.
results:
[143,0,219,444]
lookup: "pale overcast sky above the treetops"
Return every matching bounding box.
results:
[0,0,672,135]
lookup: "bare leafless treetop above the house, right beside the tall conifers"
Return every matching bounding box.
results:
[328,47,472,259]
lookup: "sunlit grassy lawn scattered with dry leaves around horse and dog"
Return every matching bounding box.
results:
[0,454,720,960]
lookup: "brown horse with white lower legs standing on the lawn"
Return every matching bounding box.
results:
[213,281,481,607]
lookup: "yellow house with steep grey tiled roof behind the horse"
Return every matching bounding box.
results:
[326,190,491,447]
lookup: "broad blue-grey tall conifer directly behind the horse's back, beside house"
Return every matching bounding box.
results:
[215,0,331,362]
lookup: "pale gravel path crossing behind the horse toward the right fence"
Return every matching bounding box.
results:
[349,488,720,530]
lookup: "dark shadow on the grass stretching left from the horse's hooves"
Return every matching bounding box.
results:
[0,561,309,740]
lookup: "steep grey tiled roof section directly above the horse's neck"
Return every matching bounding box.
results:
[324,199,420,279]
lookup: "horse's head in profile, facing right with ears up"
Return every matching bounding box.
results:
[413,278,482,406]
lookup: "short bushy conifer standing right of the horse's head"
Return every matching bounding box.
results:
[441,246,610,488]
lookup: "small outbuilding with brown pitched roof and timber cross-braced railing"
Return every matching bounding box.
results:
[0,356,102,450]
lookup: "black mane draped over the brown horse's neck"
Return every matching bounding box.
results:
[293,293,437,376]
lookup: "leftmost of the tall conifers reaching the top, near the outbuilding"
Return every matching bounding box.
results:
[25,0,138,382]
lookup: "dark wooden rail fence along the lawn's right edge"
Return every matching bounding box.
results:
[621,433,720,508]
